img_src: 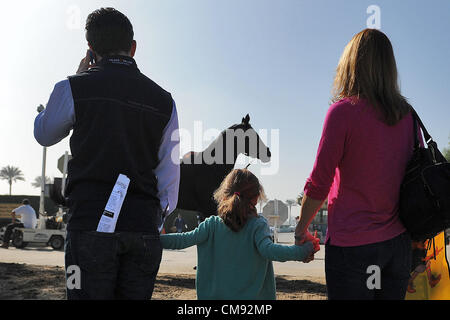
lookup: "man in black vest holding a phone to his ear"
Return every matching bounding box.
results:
[34,8,180,299]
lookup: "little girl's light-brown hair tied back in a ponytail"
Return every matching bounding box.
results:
[214,169,266,232]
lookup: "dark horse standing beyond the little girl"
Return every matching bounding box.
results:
[177,115,271,220]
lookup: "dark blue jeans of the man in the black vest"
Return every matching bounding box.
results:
[65,231,162,300]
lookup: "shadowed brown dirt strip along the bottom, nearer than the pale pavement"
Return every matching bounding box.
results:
[0,263,326,300]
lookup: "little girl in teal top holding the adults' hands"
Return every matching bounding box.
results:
[161,169,313,300]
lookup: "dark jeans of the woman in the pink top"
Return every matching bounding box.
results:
[325,233,411,300]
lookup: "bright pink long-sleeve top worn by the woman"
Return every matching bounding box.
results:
[304,98,414,247]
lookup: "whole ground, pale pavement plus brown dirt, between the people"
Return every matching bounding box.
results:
[0,233,326,300]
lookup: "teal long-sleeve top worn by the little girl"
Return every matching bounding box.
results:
[161,216,313,300]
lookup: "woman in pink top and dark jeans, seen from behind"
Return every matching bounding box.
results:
[296,29,413,299]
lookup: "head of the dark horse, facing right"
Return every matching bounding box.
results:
[227,114,272,163]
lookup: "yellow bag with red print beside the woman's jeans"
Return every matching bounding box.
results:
[406,232,450,300]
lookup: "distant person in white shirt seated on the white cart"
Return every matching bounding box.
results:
[1,199,37,249]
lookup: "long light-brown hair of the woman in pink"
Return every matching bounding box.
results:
[332,29,410,126]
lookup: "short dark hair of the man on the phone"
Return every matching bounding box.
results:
[86,8,134,57]
